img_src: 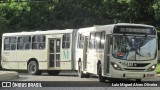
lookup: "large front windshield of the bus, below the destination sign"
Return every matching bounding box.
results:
[112,35,157,60]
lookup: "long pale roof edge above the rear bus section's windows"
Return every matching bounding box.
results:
[3,29,74,36]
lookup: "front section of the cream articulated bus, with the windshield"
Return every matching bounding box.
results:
[76,23,158,82]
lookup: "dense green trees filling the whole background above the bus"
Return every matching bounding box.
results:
[0,0,160,32]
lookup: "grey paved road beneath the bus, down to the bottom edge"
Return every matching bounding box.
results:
[0,73,160,90]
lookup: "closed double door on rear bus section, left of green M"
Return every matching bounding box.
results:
[49,38,61,67]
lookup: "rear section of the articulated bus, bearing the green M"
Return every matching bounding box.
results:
[1,29,77,75]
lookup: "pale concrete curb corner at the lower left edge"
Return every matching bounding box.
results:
[0,71,19,81]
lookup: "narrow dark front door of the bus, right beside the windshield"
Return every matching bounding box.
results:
[103,35,112,75]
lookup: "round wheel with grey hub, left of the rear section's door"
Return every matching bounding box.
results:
[28,61,41,75]
